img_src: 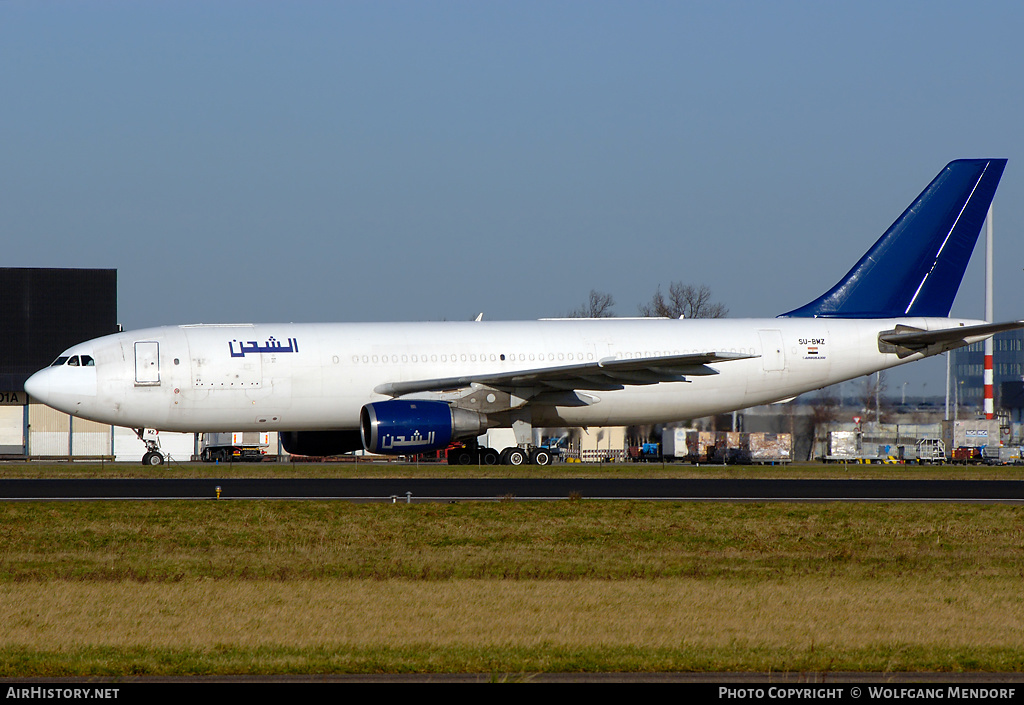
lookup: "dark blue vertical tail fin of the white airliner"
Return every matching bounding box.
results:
[782,159,1007,319]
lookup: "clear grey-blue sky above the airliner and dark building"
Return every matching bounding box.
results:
[0,0,1024,391]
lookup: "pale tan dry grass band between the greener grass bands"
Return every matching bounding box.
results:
[0,576,1024,651]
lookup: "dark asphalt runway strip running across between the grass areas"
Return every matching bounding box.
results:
[0,478,1024,503]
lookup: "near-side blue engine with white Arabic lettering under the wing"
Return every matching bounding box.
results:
[359,399,487,455]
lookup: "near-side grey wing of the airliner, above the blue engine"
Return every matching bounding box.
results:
[374,353,759,397]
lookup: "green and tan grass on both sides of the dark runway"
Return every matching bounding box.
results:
[0,465,1024,677]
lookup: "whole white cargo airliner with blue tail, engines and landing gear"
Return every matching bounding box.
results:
[25,159,1024,464]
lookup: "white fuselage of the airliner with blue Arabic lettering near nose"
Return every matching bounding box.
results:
[26,318,982,431]
